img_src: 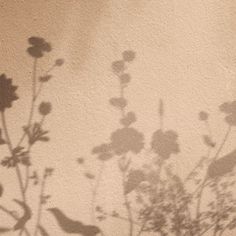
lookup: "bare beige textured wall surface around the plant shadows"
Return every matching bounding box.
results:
[0,0,236,236]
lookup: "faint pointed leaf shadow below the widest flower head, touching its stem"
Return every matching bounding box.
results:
[125,170,146,194]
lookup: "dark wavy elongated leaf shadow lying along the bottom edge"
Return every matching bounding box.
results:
[48,208,101,236]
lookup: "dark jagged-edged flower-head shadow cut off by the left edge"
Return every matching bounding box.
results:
[0,74,18,111]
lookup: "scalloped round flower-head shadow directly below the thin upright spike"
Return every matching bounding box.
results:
[151,130,179,159]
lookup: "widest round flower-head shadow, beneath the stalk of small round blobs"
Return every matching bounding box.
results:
[111,127,144,155]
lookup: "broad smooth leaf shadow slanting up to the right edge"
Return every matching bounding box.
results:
[207,149,236,178]
